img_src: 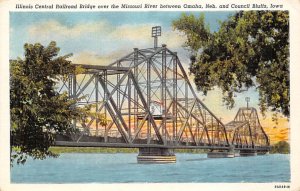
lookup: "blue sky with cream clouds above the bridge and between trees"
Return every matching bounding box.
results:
[10,11,286,125]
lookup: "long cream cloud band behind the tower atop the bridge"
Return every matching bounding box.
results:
[28,20,185,49]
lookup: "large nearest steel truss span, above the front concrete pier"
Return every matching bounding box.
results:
[57,45,231,149]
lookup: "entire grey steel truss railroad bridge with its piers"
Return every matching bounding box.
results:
[56,27,270,162]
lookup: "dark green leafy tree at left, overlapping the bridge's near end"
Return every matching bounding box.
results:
[10,42,103,163]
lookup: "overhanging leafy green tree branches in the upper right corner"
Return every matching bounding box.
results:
[173,11,290,117]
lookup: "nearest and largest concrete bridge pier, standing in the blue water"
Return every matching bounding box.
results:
[137,147,176,164]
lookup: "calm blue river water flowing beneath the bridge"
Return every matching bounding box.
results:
[11,153,290,183]
